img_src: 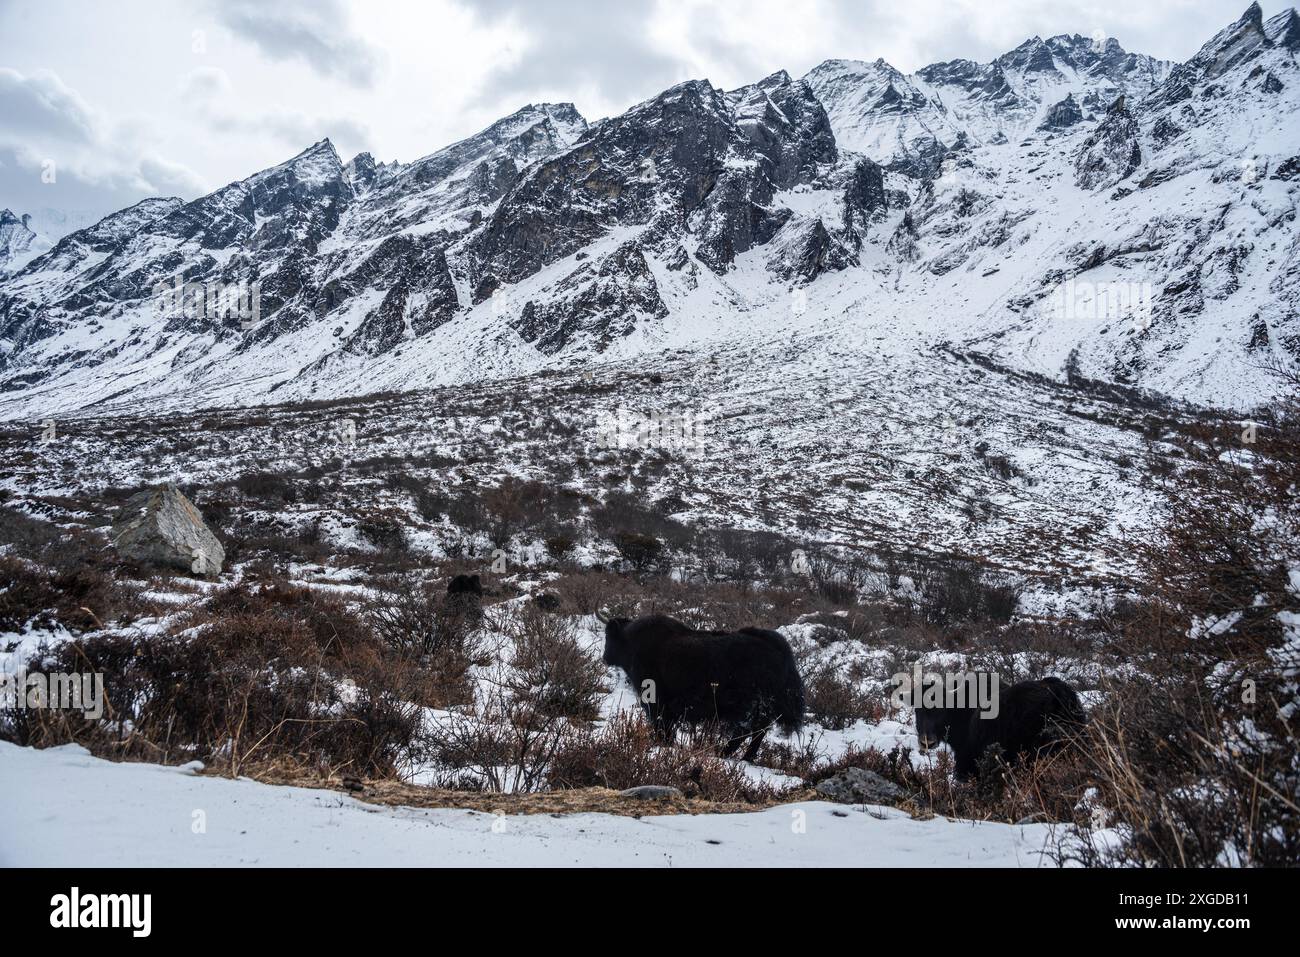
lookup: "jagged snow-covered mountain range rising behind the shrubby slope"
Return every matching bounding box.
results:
[0,5,1300,419]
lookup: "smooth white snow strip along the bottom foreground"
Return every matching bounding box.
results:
[0,742,1056,867]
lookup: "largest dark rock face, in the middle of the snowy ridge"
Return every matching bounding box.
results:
[473,73,836,282]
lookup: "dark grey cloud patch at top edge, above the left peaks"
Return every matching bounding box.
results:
[212,0,382,87]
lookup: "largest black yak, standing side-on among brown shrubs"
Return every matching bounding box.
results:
[605,615,803,761]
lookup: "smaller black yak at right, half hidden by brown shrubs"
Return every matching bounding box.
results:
[917,677,1087,780]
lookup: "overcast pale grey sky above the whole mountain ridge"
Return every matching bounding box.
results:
[0,0,1283,222]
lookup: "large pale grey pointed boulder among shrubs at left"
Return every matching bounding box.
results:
[113,485,226,577]
